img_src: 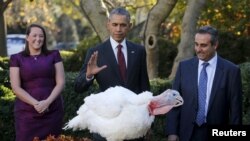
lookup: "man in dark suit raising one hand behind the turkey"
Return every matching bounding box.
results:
[75,8,150,141]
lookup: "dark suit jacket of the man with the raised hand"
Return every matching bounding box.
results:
[75,39,150,93]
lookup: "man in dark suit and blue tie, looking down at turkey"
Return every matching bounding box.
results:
[166,26,242,141]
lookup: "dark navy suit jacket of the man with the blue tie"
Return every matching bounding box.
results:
[166,56,242,141]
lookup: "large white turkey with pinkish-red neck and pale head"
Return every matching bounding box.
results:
[64,86,183,141]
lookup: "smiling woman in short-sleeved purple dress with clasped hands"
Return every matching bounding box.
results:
[10,24,65,141]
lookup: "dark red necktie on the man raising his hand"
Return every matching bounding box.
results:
[117,44,126,82]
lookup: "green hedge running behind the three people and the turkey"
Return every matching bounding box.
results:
[0,56,250,141]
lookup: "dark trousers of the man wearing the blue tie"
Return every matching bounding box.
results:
[190,124,208,141]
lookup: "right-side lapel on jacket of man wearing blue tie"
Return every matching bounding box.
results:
[208,56,224,112]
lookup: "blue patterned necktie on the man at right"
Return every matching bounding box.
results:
[196,62,209,126]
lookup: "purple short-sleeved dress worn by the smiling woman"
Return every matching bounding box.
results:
[10,50,63,141]
